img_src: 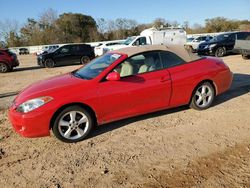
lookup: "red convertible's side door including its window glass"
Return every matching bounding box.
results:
[96,52,171,120]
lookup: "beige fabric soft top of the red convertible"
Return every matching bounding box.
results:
[112,45,200,62]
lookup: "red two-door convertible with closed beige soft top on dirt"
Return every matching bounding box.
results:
[9,45,232,142]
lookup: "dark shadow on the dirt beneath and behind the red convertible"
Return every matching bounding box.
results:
[88,73,250,138]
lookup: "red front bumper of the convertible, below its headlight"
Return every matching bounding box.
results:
[9,107,53,138]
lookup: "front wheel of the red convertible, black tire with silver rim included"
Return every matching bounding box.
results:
[52,105,94,143]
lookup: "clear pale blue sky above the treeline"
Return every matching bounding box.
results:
[0,0,250,25]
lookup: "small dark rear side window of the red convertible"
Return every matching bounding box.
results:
[160,52,185,68]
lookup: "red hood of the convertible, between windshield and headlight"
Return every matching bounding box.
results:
[15,73,89,105]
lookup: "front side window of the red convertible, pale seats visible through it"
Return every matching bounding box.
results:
[114,52,162,77]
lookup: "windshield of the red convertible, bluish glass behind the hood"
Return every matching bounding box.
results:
[72,54,121,80]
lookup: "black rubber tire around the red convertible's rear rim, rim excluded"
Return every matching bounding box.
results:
[189,82,215,110]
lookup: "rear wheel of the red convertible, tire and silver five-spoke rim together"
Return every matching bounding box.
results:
[189,82,215,110]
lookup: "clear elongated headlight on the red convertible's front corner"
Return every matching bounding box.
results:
[16,96,53,113]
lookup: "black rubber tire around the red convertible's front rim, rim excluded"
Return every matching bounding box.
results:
[52,105,94,143]
